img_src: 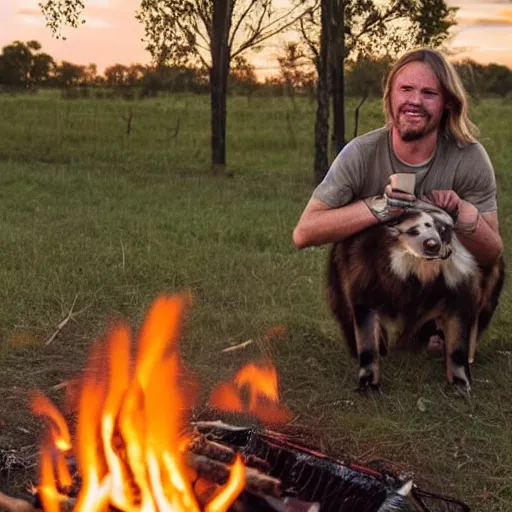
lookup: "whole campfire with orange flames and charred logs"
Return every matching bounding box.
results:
[0,295,469,512]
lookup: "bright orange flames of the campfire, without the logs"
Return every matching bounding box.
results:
[32,296,254,512]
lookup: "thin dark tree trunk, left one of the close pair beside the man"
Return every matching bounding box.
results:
[313,0,332,184]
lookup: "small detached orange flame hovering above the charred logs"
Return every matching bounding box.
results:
[209,361,291,423]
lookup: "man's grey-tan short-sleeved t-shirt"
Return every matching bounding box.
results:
[313,128,497,212]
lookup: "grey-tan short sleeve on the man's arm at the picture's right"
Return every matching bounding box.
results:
[457,143,498,213]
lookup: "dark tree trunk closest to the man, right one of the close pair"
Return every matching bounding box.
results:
[330,0,345,155]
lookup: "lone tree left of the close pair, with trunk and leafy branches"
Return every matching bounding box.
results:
[41,0,308,169]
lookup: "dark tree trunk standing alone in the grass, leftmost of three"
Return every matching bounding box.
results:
[210,0,232,172]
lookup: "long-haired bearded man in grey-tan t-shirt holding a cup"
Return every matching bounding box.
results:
[293,49,503,350]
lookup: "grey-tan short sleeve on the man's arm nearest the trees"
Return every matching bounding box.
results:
[313,140,364,208]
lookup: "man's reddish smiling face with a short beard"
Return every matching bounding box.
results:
[391,62,445,141]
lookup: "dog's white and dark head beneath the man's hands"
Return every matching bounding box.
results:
[387,209,454,260]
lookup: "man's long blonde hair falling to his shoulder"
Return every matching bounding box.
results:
[382,48,478,145]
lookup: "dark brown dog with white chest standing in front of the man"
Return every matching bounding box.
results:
[327,200,505,391]
